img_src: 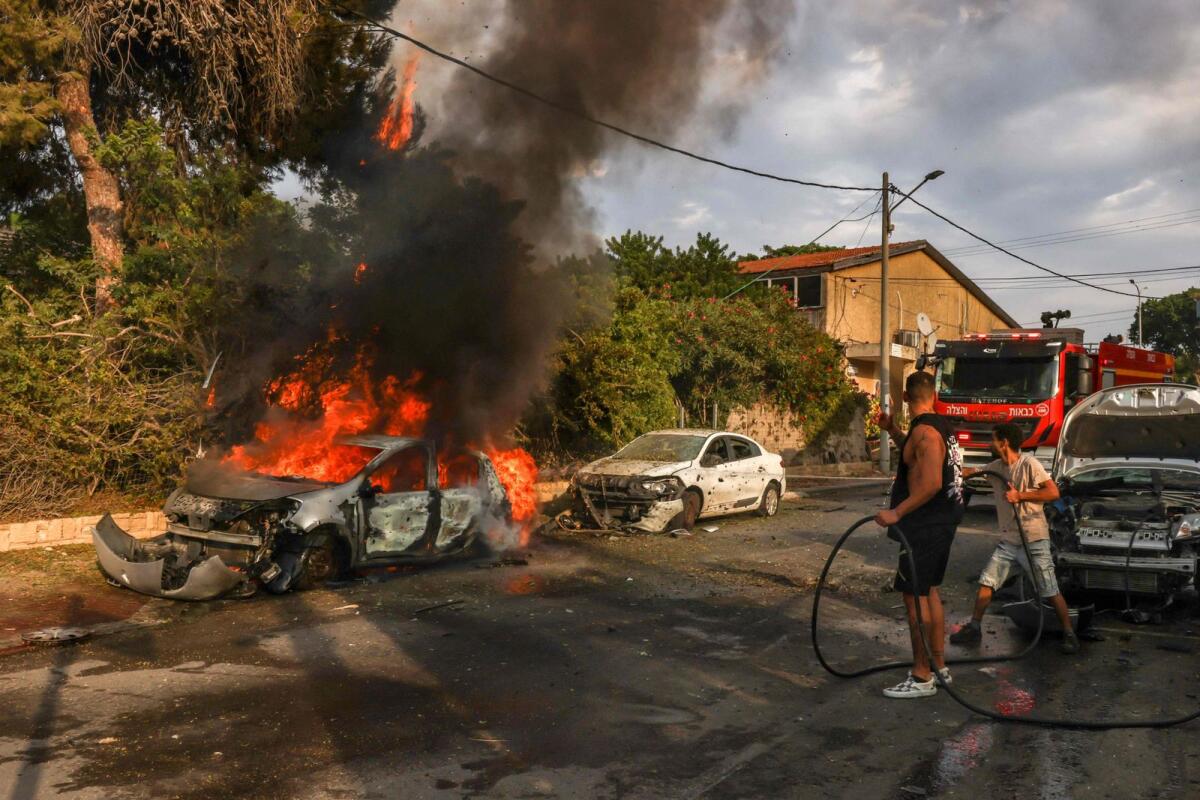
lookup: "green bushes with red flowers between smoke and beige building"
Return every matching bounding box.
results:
[526,233,864,456]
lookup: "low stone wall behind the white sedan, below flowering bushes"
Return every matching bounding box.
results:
[726,403,870,465]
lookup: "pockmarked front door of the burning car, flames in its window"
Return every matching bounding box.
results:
[362,445,437,558]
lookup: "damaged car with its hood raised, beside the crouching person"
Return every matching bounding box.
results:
[1051,384,1200,597]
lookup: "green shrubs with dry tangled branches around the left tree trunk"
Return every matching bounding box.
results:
[0,121,331,515]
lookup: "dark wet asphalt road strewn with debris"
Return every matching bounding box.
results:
[0,481,1200,800]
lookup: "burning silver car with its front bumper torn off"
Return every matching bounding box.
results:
[92,435,512,600]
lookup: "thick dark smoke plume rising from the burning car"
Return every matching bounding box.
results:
[218,0,790,441]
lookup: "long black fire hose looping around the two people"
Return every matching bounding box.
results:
[812,470,1200,730]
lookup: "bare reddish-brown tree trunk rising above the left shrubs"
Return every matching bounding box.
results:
[56,67,125,313]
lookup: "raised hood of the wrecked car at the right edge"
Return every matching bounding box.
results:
[1055,384,1200,476]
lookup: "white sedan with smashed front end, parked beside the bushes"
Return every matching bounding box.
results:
[568,428,787,533]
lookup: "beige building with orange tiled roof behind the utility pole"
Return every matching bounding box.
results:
[738,240,1019,412]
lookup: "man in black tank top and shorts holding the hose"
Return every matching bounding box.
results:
[875,372,964,698]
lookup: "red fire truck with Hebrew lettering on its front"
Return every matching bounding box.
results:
[929,327,1175,467]
